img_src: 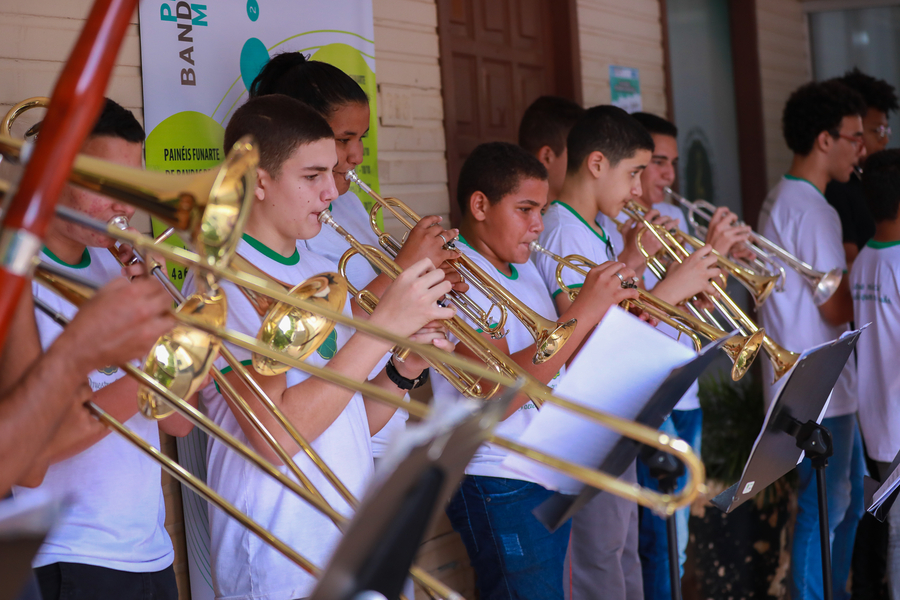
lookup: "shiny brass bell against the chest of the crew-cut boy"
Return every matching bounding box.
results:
[253,273,347,376]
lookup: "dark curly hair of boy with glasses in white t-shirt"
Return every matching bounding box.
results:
[781,80,866,156]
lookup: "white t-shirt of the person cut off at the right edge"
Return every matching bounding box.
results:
[850,240,900,462]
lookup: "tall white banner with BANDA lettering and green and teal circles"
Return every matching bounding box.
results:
[140,0,379,600]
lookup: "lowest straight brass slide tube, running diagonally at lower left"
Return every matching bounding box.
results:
[86,402,321,577]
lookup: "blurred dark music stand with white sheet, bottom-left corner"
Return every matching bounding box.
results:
[0,497,62,600]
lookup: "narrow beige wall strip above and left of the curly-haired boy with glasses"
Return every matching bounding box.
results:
[756,0,812,187]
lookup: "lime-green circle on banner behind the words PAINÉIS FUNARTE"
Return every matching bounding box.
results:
[147,111,225,173]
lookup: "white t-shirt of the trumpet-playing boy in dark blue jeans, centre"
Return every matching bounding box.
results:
[431,237,565,479]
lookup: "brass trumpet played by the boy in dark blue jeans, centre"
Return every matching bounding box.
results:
[530,241,765,381]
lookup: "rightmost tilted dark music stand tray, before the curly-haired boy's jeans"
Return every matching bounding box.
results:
[711,330,862,513]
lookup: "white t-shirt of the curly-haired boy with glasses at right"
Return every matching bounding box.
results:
[759,175,857,417]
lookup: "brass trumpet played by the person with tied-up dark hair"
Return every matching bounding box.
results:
[347,171,575,364]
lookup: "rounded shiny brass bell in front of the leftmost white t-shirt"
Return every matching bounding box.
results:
[138,288,228,419]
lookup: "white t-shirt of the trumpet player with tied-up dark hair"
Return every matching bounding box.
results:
[298,190,409,457]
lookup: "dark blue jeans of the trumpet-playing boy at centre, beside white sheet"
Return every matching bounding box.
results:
[447,475,572,600]
